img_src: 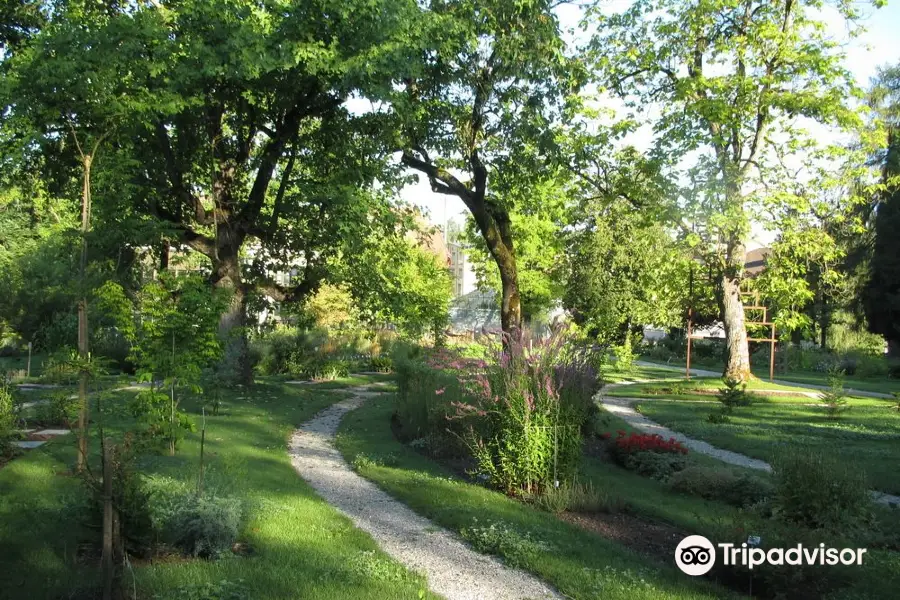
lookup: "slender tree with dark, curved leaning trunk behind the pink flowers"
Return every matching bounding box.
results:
[391,0,567,335]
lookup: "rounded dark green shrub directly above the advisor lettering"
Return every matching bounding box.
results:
[773,449,871,530]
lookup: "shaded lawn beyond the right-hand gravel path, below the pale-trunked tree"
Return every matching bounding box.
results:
[638,399,900,494]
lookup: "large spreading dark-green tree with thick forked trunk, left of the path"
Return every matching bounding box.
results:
[2,0,414,379]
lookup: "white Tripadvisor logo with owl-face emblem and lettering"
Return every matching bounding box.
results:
[675,535,866,576]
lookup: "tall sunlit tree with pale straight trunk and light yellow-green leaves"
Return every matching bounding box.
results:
[592,0,872,381]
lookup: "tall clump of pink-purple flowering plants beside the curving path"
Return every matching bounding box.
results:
[396,331,599,495]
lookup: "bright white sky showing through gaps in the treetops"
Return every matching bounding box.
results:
[400,0,900,239]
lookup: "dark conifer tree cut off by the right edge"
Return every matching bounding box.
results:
[864,65,900,353]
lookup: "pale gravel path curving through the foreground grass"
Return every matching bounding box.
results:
[289,388,560,600]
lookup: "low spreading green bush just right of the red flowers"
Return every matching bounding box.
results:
[668,466,774,507]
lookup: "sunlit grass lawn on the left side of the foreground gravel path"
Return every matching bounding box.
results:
[0,377,432,600]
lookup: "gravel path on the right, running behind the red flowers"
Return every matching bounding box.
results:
[597,380,900,505]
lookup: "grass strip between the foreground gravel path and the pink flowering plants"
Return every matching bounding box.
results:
[337,395,729,599]
